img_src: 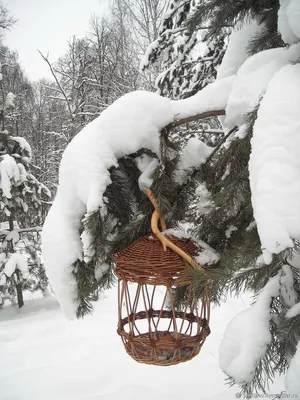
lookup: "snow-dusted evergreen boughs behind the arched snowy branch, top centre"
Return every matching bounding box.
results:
[142,0,228,99]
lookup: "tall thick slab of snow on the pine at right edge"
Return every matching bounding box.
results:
[249,65,300,263]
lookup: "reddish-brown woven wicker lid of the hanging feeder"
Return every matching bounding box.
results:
[116,236,198,286]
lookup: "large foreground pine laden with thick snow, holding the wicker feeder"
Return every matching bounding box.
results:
[43,0,300,395]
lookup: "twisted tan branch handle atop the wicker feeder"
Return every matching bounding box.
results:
[145,189,202,269]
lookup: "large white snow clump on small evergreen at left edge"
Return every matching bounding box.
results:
[0,154,20,199]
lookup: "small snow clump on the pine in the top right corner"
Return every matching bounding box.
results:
[278,0,299,44]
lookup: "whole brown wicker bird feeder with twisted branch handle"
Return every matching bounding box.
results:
[116,190,210,366]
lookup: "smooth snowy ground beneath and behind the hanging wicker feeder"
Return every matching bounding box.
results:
[0,289,282,400]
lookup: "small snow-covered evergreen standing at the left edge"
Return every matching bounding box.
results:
[0,56,50,308]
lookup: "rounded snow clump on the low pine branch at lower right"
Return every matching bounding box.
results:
[219,272,281,383]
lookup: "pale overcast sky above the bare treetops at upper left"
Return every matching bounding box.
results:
[2,0,107,80]
